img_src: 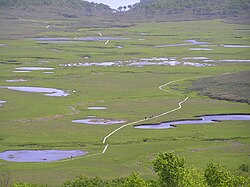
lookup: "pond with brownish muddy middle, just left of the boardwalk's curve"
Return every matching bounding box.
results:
[72,118,126,125]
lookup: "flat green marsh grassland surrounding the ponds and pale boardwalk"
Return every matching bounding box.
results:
[0,20,250,187]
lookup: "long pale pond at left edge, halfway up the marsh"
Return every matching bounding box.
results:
[0,86,69,97]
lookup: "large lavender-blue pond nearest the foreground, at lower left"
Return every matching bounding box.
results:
[0,150,87,162]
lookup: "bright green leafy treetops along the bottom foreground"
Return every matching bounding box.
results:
[13,152,249,187]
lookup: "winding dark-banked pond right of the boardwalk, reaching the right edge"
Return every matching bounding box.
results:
[134,114,250,129]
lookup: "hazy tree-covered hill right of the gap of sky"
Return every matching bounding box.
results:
[131,0,250,15]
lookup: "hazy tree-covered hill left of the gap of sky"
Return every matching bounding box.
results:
[0,0,111,18]
